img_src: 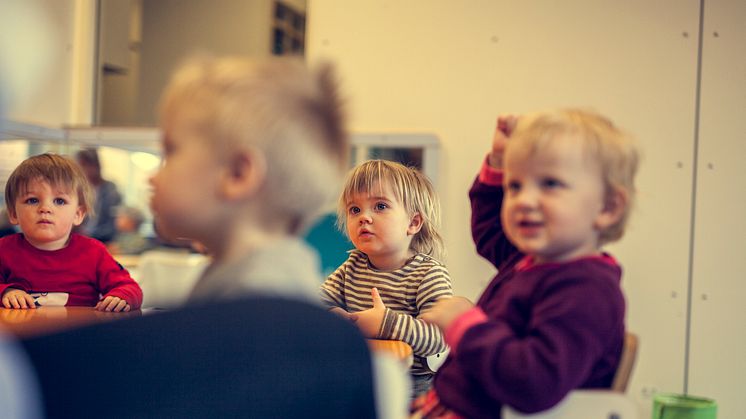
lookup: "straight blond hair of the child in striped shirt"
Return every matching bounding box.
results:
[337,160,445,260]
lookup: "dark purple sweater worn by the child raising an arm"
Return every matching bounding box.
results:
[435,180,625,418]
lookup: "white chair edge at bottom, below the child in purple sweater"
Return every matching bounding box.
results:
[502,390,639,419]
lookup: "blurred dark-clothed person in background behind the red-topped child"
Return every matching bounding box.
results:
[75,148,122,243]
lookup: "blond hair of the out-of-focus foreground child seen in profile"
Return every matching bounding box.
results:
[160,57,349,234]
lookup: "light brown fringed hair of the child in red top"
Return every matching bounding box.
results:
[5,153,93,217]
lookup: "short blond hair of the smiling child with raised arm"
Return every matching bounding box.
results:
[508,109,640,244]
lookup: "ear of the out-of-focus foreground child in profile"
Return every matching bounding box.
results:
[220,147,267,201]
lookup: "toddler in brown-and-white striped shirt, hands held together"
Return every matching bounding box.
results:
[321,160,453,395]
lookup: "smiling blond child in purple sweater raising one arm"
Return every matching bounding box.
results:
[414,110,638,418]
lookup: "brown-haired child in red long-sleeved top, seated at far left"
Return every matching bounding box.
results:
[0,154,142,311]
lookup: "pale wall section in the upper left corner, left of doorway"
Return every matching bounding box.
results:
[0,0,95,126]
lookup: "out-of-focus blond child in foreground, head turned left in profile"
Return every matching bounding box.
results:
[151,58,348,304]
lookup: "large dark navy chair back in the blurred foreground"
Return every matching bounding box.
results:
[22,297,376,418]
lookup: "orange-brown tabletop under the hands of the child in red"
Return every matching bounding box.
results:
[0,307,142,337]
